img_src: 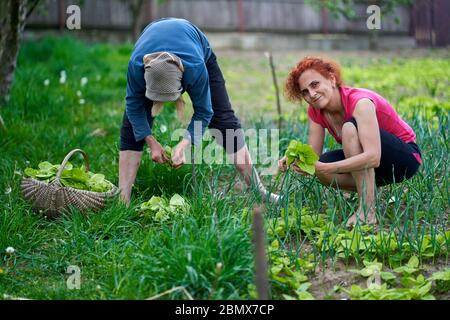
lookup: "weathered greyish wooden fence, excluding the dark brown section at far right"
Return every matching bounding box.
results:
[28,0,410,35]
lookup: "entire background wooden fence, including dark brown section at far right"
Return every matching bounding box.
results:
[27,0,450,46]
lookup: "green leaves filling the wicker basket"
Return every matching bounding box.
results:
[24,161,113,192]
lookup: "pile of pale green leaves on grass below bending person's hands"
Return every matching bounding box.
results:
[137,194,189,222]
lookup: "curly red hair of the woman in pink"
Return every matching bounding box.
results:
[284,57,344,101]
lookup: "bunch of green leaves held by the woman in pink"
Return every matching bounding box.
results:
[285,140,319,175]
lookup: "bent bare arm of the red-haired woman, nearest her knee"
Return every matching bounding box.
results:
[316,99,381,173]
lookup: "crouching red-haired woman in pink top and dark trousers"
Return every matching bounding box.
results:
[279,57,422,226]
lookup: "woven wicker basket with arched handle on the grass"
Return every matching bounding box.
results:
[21,149,119,218]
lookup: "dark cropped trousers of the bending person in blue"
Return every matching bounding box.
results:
[120,52,245,153]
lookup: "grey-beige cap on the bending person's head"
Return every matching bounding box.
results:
[144,52,184,102]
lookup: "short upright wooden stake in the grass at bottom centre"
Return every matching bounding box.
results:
[253,206,269,300]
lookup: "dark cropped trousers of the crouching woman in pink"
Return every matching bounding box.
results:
[319,118,422,186]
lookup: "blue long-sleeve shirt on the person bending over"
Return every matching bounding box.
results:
[125,18,213,144]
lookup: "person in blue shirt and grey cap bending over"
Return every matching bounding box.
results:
[119,18,278,203]
